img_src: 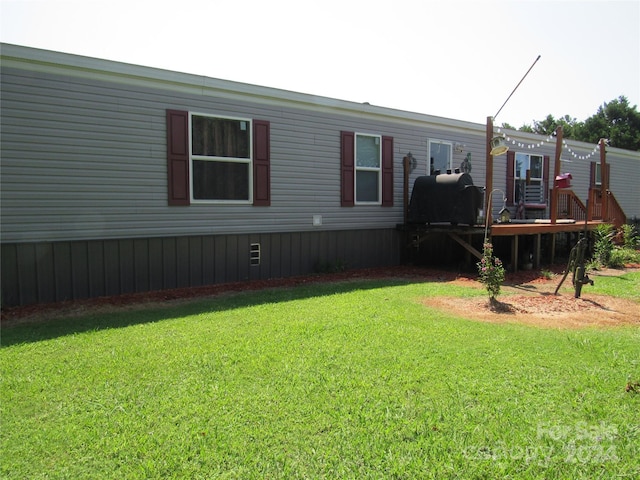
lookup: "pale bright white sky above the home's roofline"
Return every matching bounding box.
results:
[0,0,640,127]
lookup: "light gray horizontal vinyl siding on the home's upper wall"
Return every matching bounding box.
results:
[0,46,640,243]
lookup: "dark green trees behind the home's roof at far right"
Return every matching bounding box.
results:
[502,96,640,150]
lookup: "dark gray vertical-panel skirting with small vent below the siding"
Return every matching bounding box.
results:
[2,229,401,307]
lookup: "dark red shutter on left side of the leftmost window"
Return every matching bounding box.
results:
[167,110,191,205]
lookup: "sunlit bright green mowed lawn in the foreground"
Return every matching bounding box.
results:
[0,274,640,479]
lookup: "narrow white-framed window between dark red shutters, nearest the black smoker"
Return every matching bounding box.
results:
[354,133,382,205]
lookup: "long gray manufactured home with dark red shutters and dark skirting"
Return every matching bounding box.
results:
[0,44,640,306]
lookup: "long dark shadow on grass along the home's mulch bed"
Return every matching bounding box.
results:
[0,275,451,348]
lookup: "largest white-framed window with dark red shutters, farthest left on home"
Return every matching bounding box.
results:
[189,113,253,204]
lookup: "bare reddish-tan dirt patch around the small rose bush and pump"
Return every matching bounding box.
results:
[423,269,640,328]
